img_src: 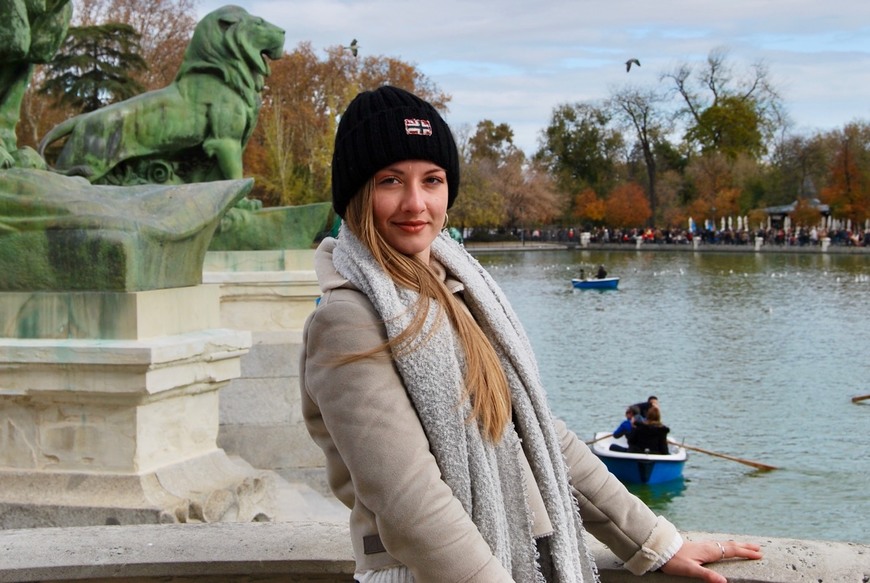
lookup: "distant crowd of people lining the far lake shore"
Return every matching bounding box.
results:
[516,227,870,247]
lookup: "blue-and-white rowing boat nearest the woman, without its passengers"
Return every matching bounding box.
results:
[590,432,688,484]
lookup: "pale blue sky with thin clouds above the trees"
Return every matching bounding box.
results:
[198,0,870,154]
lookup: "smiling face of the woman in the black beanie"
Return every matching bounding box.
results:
[373,160,448,263]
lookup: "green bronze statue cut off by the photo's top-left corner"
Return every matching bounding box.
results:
[0,0,72,168]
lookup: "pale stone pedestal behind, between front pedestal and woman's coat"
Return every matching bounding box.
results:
[203,249,327,492]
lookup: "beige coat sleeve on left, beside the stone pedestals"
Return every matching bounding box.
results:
[300,290,512,583]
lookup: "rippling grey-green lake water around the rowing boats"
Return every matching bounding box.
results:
[477,250,870,544]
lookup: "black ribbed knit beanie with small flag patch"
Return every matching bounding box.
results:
[332,85,459,218]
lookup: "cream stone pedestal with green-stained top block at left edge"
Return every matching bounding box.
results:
[0,285,273,528]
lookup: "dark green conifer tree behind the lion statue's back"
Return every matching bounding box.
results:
[40,22,148,112]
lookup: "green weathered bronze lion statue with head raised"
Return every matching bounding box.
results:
[39,6,284,185]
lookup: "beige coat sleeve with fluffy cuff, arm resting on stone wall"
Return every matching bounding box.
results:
[555,420,682,575]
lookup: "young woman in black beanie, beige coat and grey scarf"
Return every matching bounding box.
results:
[300,87,761,583]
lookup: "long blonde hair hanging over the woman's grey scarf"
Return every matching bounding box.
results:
[344,179,511,442]
